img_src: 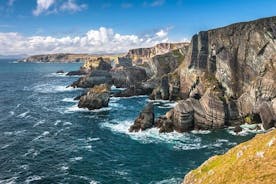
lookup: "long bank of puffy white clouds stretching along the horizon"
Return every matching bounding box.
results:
[0,27,169,55]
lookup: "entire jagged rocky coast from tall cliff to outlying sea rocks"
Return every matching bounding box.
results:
[63,17,276,132]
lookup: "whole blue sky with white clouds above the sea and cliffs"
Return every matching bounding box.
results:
[0,0,276,55]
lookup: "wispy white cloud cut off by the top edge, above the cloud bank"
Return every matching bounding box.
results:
[33,0,87,16]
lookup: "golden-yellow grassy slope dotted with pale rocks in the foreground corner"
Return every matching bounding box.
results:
[183,130,276,184]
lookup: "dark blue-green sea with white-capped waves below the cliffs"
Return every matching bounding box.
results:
[0,60,252,184]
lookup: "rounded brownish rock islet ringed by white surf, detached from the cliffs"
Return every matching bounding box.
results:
[78,84,110,110]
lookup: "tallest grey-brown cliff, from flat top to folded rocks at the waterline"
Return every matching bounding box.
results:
[155,17,276,131]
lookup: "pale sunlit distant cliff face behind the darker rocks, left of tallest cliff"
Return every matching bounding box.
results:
[126,43,189,65]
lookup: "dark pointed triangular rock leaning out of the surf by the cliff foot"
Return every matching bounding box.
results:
[129,103,154,132]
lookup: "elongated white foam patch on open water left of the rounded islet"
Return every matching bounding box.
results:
[31,84,81,93]
